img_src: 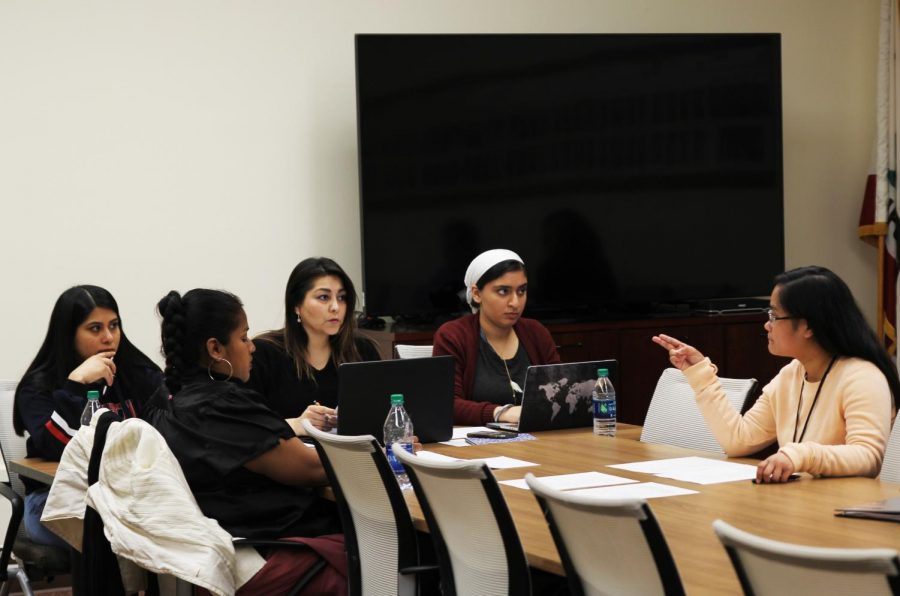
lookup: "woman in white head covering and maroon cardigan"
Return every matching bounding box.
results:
[434,249,559,425]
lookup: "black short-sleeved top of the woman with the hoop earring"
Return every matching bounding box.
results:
[152,370,340,538]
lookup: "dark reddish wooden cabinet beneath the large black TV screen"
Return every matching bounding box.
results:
[365,313,788,424]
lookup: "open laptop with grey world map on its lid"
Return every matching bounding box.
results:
[491,359,619,432]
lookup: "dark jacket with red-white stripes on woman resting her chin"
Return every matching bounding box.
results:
[16,365,163,493]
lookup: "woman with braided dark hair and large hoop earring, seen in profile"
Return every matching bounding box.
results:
[152,289,346,594]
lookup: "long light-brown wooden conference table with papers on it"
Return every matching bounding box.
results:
[10,424,900,595]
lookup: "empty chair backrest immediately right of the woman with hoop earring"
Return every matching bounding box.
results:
[303,420,418,594]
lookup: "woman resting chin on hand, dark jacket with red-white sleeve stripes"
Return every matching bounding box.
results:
[12,285,162,545]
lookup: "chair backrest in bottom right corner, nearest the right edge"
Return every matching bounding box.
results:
[713,519,900,596]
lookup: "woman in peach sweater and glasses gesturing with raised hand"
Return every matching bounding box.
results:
[653,267,900,482]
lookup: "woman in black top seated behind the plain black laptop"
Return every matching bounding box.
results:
[249,257,379,434]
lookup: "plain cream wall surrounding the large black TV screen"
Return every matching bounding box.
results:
[0,0,878,378]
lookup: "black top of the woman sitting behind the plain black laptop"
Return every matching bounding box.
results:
[247,337,381,418]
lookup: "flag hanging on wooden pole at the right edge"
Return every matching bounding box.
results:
[859,0,900,355]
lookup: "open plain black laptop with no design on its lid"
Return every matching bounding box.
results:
[337,356,455,443]
